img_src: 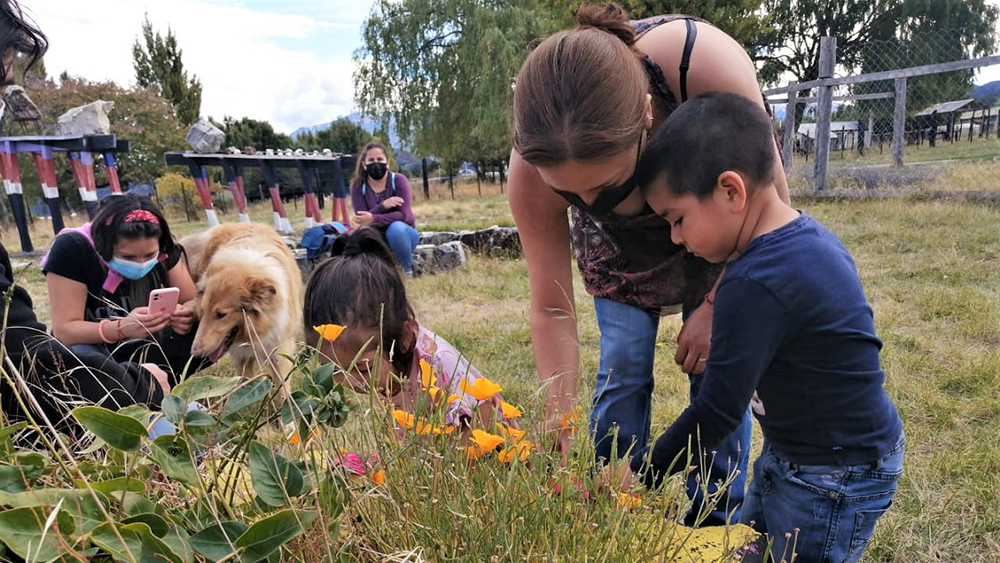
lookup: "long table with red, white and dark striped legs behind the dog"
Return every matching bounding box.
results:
[163,152,353,234]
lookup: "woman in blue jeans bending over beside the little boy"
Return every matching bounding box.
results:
[508,4,788,523]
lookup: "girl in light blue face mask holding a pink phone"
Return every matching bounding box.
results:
[42,194,208,383]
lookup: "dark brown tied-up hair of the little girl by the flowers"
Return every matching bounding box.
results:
[302,227,416,377]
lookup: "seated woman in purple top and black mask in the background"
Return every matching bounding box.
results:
[351,143,420,275]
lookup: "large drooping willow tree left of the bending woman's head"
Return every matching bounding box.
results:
[354,0,556,165]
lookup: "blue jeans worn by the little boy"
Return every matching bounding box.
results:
[740,435,906,563]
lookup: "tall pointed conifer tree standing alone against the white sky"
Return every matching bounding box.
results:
[132,16,201,125]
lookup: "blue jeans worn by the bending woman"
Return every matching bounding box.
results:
[590,297,753,525]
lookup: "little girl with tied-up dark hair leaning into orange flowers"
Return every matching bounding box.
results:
[302,227,500,428]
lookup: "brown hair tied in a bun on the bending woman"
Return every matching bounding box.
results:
[514,4,649,166]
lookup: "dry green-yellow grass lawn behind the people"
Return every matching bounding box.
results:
[3,178,1000,563]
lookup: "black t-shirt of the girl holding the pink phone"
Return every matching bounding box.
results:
[42,233,181,322]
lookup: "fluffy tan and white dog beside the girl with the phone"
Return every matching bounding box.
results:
[180,223,302,398]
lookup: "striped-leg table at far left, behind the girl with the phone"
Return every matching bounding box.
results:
[0,135,129,252]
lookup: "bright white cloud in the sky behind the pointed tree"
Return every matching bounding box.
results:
[23,0,364,132]
